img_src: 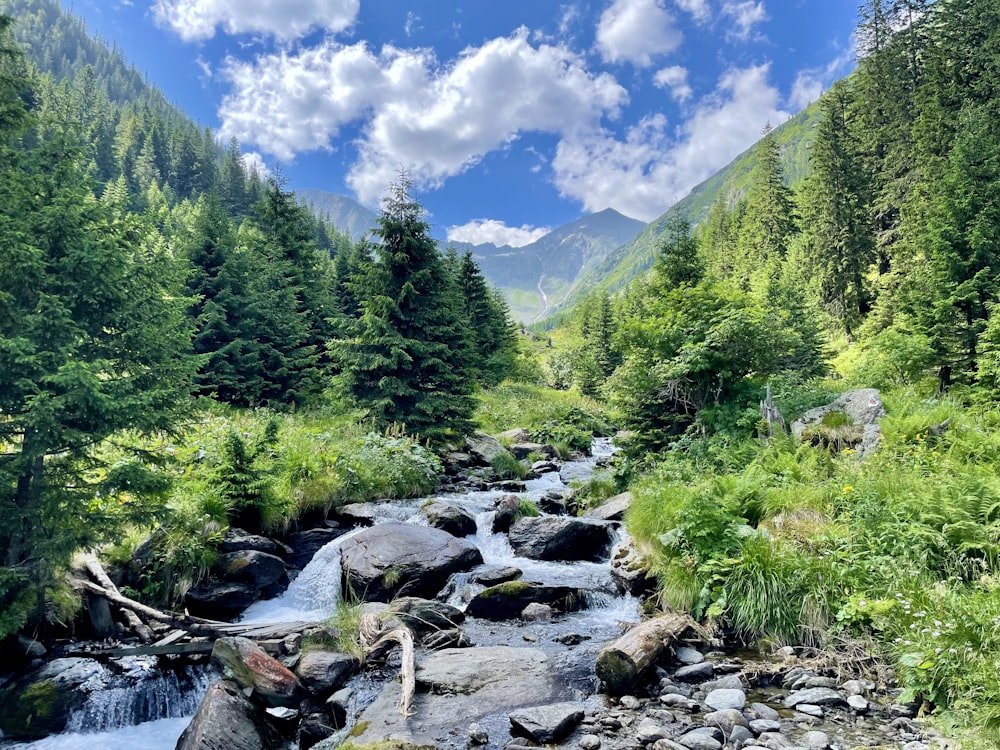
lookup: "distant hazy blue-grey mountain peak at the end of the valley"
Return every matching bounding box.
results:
[450,208,644,323]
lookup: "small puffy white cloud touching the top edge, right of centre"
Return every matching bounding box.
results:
[597,0,684,68]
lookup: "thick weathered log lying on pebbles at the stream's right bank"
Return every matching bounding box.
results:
[596,614,696,695]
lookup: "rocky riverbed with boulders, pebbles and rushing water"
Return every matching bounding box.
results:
[0,439,941,750]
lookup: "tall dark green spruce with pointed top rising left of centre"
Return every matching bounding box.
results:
[333,174,475,442]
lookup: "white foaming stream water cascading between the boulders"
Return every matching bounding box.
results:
[7,439,638,750]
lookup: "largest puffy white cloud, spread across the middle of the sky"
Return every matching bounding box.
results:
[219,28,627,204]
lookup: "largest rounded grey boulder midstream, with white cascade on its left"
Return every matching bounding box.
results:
[341,523,483,601]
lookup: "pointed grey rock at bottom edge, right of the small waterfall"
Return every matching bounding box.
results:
[176,681,282,750]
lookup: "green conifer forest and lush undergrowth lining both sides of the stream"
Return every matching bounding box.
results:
[0,0,1000,748]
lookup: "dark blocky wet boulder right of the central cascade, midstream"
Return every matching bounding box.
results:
[509,516,611,562]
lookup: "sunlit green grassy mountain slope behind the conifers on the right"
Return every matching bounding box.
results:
[548,102,819,322]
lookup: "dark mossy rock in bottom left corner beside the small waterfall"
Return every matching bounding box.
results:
[0,659,102,740]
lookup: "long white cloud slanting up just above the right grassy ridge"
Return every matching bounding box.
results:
[553,65,789,221]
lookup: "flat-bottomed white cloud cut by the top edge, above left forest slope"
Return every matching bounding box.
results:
[153,0,360,42]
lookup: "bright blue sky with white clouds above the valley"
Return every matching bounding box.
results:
[74,0,856,244]
